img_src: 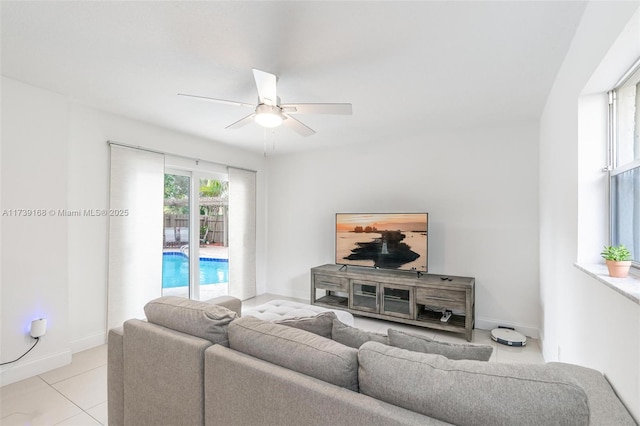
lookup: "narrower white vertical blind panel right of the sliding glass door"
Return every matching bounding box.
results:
[229,167,256,300]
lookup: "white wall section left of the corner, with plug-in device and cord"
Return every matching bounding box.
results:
[0,78,71,385]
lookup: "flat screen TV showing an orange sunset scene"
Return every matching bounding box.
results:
[336,213,429,272]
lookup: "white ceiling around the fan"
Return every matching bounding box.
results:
[1,0,585,154]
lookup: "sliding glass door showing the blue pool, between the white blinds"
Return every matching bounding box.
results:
[162,169,229,300]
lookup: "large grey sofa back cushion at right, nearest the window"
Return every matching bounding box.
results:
[358,342,589,426]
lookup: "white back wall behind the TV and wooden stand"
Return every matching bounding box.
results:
[267,123,539,336]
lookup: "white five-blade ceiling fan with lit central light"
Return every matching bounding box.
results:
[178,68,351,136]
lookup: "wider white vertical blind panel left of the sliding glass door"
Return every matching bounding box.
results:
[107,145,164,329]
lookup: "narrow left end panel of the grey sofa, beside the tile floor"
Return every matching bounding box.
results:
[107,327,124,426]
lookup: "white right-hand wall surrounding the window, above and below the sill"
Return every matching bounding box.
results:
[540,2,640,418]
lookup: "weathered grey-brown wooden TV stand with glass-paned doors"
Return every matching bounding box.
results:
[311,265,475,341]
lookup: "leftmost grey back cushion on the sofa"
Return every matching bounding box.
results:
[144,296,237,346]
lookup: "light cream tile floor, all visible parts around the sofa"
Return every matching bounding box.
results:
[0,294,544,426]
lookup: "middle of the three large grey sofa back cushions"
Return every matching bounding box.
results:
[229,316,358,391]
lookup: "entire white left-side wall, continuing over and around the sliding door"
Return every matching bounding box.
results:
[1,78,266,384]
